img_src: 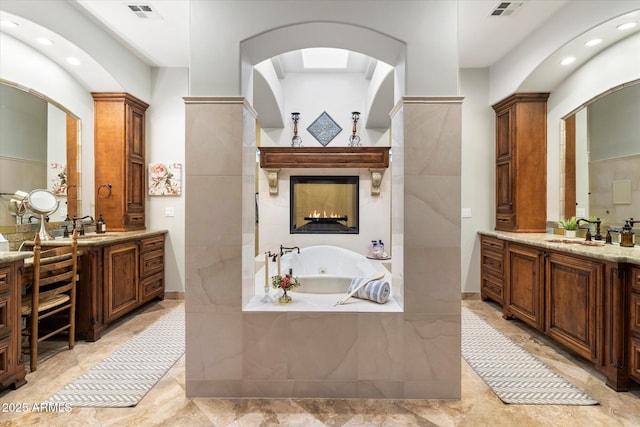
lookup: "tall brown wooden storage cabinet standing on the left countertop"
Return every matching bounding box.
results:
[92,92,149,231]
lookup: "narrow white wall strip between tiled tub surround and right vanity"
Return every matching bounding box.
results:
[460,68,495,292]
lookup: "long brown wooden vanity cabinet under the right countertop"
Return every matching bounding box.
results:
[481,235,640,391]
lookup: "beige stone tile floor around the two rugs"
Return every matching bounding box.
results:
[0,300,640,427]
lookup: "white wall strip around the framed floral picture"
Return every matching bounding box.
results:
[146,68,189,292]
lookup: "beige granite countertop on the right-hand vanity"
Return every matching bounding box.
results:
[479,231,640,265]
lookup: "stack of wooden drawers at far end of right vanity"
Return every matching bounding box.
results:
[480,236,505,305]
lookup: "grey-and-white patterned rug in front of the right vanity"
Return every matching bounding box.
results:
[462,307,598,405]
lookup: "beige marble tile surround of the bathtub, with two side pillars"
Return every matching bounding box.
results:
[185,98,461,399]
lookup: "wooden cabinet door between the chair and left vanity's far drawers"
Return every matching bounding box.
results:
[104,242,139,322]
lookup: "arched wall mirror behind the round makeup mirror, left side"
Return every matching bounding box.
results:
[0,80,81,226]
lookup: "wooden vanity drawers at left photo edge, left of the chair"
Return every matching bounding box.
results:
[0,260,27,390]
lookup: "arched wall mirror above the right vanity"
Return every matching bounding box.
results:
[560,80,640,225]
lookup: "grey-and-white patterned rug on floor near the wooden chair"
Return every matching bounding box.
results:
[48,307,185,408]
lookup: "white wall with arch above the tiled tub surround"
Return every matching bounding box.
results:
[190,0,458,96]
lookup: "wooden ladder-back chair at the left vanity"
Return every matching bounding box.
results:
[22,230,78,372]
